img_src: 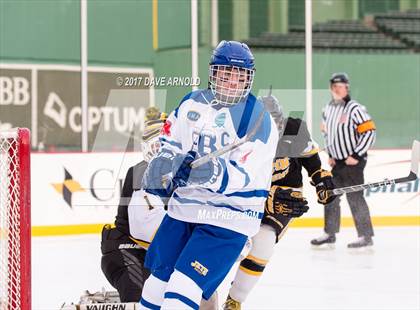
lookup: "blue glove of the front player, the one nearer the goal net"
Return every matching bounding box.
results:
[142,151,174,197]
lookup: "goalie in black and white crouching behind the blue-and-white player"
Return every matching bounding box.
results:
[100,108,218,310]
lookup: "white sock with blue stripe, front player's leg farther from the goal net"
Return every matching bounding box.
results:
[161,270,203,310]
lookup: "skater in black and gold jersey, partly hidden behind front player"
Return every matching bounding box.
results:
[224,95,334,310]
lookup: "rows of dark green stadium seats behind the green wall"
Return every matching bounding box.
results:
[247,10,420,52]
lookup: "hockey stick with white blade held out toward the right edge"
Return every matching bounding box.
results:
[327,140,420,196]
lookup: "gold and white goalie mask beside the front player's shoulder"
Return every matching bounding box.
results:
[141,107,167,162]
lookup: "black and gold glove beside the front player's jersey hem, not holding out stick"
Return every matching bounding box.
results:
[265,186,309,217]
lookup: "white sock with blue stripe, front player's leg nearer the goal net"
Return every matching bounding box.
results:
[138,275,168,310]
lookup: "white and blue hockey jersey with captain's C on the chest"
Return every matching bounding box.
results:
[149,89,278,236]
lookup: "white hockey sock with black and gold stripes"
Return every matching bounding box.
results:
[229,224,276,303]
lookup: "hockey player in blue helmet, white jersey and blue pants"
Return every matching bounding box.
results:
[140,41,278,309]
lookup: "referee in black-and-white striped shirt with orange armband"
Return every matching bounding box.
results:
[311,73,376,248]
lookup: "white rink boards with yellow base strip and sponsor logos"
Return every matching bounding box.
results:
[31,150,420,236]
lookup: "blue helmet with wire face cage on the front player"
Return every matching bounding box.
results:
[209,41,255,105]
